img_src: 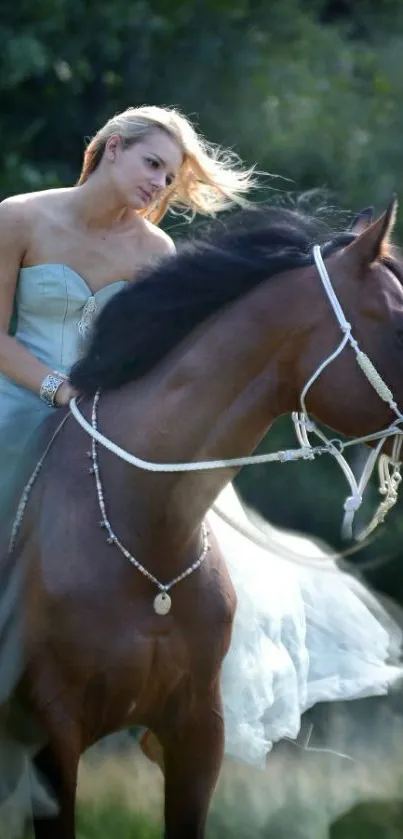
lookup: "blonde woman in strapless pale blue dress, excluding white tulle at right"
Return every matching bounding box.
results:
[0,107,253,839]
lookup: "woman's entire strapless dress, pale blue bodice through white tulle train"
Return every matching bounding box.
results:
[0,264,402,836]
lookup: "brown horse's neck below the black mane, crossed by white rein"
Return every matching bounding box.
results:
[108,279,316,540]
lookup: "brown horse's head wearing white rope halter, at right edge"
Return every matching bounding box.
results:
[299,199,403,436]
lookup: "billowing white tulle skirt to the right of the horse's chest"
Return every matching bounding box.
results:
[208,486,403,766]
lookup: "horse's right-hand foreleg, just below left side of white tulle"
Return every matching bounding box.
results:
[161,702,224,839]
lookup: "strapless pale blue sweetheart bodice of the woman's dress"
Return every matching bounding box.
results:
[15,263,126,372]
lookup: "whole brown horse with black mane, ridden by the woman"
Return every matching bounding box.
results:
[6,197,403,839]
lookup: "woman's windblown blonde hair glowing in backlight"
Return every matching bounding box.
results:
[78,106,255,224]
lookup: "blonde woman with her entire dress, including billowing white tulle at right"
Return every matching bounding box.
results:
[0,107,400,832]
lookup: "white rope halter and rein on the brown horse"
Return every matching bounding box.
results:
[66,245,403,541]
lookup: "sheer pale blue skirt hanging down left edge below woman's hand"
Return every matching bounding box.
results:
[0,384,55,839]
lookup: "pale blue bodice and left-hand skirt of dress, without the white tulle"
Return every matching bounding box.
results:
[0,264,125,839]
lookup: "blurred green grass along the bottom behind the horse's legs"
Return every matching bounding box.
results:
[74,740,403,839]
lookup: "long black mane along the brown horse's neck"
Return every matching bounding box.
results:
[70,207,354,394]
